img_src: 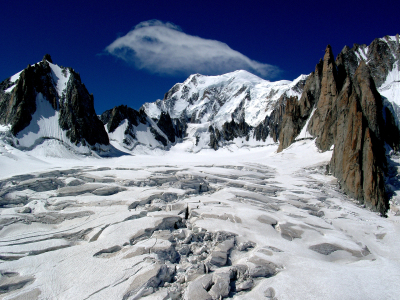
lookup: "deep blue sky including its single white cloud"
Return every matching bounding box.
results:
[0,0,400,114]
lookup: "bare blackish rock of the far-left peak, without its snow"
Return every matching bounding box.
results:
[0,54,109,145]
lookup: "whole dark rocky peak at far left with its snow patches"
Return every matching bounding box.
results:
[0,55,109,152]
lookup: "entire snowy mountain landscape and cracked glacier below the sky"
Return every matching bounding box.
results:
[0,35,400,300]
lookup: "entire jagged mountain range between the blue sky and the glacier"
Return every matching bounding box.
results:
[0,35,400,215]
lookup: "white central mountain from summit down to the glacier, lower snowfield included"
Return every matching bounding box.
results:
[143,70,308,152]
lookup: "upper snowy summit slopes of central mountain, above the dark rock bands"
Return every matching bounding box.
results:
[143,70,307,127]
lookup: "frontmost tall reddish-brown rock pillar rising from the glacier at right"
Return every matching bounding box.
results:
[330,63,388,214]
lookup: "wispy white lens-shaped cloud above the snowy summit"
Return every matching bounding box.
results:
[105,20,279,77]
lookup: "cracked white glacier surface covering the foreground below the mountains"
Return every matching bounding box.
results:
[0,139,400,299]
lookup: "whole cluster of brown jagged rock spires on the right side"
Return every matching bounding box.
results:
[279,43,400,215]
